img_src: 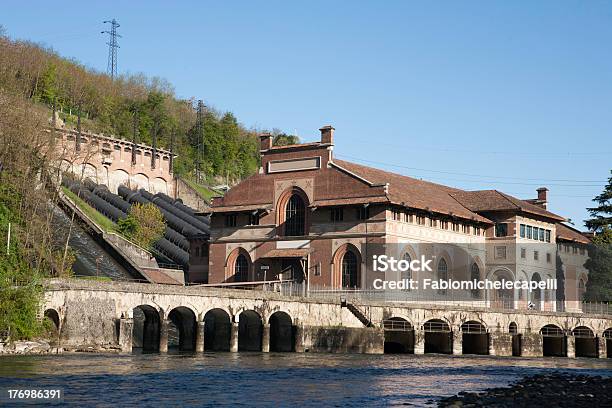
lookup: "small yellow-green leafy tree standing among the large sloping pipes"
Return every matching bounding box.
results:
[117,203,166,249]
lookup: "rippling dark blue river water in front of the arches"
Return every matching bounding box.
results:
[0,353,612,407]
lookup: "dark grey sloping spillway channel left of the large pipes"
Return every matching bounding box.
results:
[53,206,132,279]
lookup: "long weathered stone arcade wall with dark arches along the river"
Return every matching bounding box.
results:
[41,279,612,358]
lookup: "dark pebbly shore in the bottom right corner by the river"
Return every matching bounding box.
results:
[438,373,612,408]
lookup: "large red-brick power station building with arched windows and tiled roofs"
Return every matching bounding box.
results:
[208,126,588,306]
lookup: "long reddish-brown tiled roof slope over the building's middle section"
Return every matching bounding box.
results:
[333,159,491,223]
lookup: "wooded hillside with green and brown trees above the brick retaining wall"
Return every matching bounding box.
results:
[0,26,259,184]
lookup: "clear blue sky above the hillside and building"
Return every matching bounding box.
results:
[0,0,612,228]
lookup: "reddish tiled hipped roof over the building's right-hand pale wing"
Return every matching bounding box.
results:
[451,190,565,221]
